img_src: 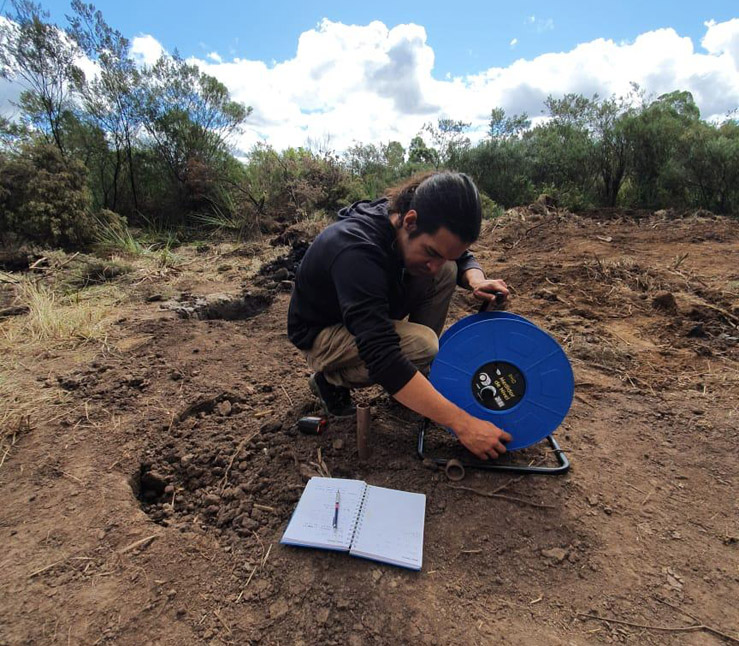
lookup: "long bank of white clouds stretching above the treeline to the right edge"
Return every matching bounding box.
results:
[182,16,739,150]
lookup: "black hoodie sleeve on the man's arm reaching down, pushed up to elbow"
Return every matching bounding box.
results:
[331,245,417,395]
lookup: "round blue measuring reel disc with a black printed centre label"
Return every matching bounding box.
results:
[429,312,575,450]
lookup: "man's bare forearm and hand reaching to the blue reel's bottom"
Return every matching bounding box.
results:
[393,372,512,460]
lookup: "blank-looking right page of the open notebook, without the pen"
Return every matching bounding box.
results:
[350,486,426,570]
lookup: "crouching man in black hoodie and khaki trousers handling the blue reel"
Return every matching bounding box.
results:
[288,172,511,460]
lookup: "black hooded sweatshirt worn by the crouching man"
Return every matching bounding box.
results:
[287,198,480,395]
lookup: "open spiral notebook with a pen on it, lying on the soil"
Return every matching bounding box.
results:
[280,478,426,570]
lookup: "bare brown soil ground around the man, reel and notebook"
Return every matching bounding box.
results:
[0,209,739,646]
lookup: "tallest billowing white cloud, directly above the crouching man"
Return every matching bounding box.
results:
[190,20,446,149]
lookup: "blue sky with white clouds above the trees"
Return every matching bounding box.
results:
[0,0,739,152]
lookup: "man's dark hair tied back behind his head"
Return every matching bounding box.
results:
[385,171,482,244]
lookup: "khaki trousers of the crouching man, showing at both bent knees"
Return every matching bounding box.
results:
[303,262,457,388]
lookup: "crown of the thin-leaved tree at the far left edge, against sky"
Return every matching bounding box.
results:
[0,0,80,158]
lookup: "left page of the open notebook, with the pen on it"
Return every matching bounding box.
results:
[280,477,367,551]
